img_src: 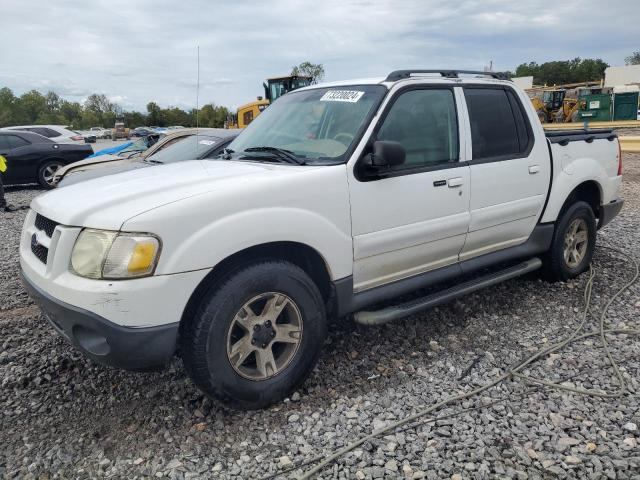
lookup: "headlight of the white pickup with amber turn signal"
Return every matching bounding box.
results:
[71,228,160,279]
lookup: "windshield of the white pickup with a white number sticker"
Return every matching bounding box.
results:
[228,85,386,163]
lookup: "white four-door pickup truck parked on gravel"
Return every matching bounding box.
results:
[20,70,622,408]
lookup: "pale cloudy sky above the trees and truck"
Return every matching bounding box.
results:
[0,0,640,110]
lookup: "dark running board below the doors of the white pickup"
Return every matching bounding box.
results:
[353,258,542,325]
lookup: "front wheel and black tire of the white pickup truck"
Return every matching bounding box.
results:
[180,260,326,410]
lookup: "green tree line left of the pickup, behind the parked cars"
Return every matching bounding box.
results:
[0,87,229,130]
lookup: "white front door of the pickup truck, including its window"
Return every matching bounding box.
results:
[349,86,469,292]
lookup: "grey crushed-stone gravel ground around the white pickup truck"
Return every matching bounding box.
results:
[0,154,640,480]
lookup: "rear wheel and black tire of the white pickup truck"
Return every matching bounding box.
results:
[543,201,596,282]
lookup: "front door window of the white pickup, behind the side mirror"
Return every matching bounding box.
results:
[376,89,459,170]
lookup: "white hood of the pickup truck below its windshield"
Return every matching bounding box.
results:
[31,160,312,230]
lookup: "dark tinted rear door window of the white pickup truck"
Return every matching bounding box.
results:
[464,88,531,160]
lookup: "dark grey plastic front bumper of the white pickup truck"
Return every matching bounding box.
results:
[22,272,178,371]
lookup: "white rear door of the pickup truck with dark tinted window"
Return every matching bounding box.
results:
[460,85,551,260]
